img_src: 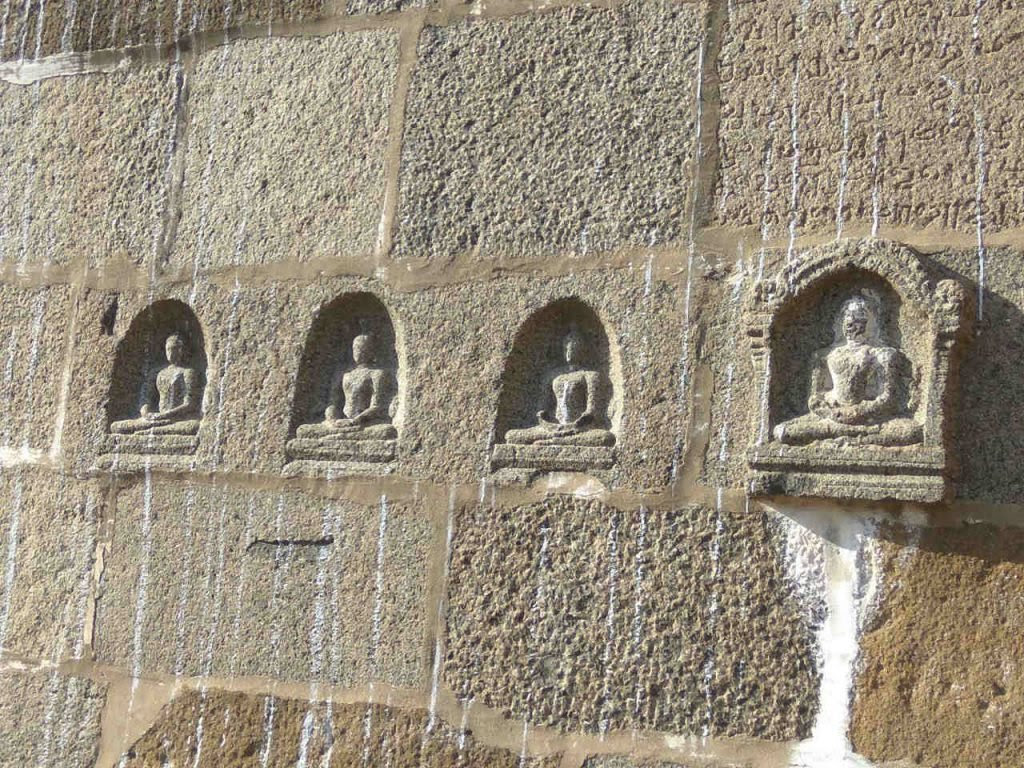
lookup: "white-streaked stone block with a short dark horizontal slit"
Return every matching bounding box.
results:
[97,478,432,687]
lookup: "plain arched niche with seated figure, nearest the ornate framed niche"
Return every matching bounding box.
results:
[492,298,620,475]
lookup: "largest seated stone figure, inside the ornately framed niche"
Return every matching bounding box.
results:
[773,296,924,445]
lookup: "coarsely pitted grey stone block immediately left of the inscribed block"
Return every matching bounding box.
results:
[395,0,703,263]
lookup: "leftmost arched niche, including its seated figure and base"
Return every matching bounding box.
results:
[97,299,207,470]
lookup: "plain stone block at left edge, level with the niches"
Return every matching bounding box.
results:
[0,285,74,457]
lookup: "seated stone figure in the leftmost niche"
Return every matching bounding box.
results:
[111,334,203,435]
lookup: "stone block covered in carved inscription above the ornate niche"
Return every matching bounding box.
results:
[713,0,1024,238]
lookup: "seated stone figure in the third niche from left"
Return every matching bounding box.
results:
[505,330,615,445]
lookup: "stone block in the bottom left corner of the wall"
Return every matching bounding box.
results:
[0,671,105,768]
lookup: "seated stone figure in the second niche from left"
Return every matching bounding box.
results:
[296,334,397,441]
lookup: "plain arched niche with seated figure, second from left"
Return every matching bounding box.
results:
[285,293,401,476]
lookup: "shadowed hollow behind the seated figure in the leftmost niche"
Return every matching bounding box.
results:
[106,299,207,427]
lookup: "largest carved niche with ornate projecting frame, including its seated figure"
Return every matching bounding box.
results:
[746,241,967,503]
